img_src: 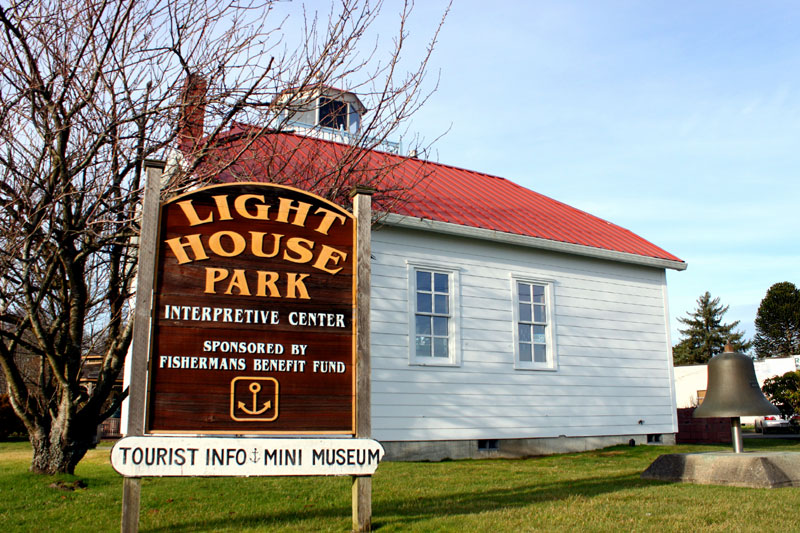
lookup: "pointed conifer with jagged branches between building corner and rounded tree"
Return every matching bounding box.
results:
[672,291,752,365]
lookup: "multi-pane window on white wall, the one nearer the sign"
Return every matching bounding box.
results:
[409,266,458,365]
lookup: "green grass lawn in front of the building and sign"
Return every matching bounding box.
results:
[0,439,800,533]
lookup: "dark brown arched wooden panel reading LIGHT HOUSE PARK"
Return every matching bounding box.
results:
[145,183,356,434]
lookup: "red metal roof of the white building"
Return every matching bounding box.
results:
[198,128,682,263]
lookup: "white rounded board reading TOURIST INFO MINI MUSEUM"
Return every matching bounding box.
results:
[111,436,384,477]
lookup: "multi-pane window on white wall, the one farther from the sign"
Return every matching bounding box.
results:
[512,279,556,370]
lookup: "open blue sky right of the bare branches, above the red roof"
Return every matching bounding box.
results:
[372,0,800,343]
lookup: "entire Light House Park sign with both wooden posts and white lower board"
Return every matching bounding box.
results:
[117,181,383,532]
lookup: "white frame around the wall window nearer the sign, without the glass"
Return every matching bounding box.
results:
[406,262,461,366]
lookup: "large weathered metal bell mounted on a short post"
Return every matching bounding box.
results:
[692,344,780,418]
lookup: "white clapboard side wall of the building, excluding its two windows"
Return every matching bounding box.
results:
[371,228,677,441]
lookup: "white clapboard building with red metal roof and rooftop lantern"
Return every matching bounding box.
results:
[183,85,686,459]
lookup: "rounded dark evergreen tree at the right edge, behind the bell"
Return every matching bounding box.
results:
[753,281,800,357]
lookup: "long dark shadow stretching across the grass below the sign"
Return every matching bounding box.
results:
[147,473,668,532]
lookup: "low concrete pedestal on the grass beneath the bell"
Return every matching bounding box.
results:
[641,452,800,488]
